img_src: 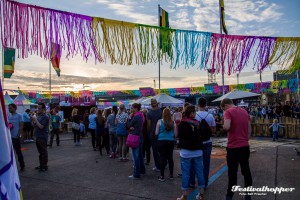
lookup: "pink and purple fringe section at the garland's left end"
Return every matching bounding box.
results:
[0,0,102,62]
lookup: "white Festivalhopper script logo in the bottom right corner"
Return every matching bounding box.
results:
[231,185,295,195]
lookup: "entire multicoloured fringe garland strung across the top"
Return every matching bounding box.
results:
[0,0,300,75]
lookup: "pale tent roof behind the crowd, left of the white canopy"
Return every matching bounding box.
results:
[141,94,184,107]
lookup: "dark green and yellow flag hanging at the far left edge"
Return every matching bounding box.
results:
[3,48,16,78]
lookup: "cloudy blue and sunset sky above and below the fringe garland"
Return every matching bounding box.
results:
[5,0,300,90]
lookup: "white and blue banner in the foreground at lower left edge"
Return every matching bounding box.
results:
[0,83,23,200]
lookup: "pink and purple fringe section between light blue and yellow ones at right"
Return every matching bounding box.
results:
[206,33,276,75]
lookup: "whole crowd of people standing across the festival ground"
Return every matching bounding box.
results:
[8,98,299,200]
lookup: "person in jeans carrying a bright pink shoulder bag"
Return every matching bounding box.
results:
[128,103,146,180]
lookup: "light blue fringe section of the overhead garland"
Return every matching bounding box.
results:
[172,30,211,69]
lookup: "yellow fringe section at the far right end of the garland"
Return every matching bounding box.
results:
[269,37,300,71]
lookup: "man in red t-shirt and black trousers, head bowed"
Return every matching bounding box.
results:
[221,99,252,200]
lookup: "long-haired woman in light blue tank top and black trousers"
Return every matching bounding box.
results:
[155,108,177,181]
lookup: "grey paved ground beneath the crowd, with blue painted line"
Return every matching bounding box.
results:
[19,134,300,200]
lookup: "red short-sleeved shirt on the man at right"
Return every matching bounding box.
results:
[224,107,250,148]
